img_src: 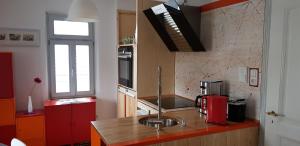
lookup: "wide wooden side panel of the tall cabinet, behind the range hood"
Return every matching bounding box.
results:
[136,0,175,98]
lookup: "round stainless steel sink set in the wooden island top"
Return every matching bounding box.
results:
[139,116,179,128]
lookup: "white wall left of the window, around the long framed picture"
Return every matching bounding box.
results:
[0,0,56,110]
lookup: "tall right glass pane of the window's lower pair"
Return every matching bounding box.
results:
[76,45,90,91]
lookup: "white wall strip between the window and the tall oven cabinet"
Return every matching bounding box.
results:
[95,0,118,119]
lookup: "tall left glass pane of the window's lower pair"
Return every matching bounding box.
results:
[54,45,70,93]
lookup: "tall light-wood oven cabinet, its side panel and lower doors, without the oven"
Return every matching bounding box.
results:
[117,0,175,117]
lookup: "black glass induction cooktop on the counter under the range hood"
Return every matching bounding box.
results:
[144,95,194,109]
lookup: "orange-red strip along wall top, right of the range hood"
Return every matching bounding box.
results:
[200,0,248,12]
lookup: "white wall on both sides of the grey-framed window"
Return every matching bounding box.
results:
[0,0,117,118]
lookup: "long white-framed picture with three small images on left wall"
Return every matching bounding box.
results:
[0,28,40,47]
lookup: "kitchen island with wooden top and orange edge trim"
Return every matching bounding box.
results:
[91,109,259,146]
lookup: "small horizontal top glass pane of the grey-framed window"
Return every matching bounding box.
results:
[54,20,89,36]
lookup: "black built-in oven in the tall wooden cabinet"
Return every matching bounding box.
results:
[118,46,133,88]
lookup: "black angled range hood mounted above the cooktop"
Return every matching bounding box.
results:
[144,0,205,52]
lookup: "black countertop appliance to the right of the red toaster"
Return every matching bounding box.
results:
[228,98,246,122]
